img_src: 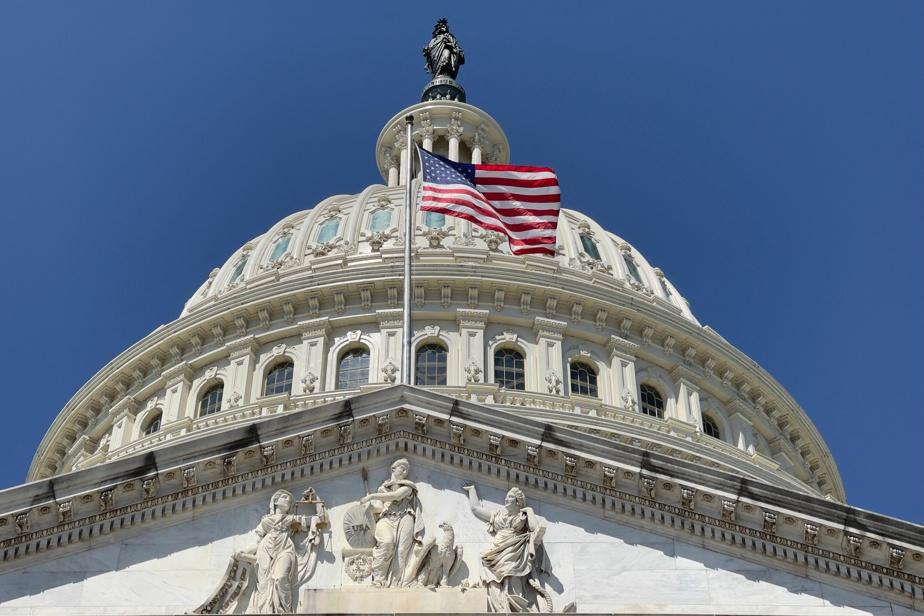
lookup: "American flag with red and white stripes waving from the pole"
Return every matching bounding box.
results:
[419,148,561,255]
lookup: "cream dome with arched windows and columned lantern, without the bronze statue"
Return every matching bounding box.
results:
[28,45,844,501]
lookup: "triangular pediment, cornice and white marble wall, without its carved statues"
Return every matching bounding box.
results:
[0,387,922,614]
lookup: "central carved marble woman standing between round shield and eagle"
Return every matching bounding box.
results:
[359,458,424,586]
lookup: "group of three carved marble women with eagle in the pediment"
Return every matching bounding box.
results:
[195,458,552,614]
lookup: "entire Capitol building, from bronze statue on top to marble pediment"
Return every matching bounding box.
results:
[0,20,924,615]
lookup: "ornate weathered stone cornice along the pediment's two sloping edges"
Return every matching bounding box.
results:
[0,386,924,605]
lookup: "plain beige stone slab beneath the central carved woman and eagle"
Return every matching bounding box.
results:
[299,586,488,614]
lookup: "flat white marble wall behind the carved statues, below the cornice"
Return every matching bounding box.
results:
[0,460,914,616]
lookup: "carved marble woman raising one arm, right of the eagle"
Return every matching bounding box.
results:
[463,485,552,613]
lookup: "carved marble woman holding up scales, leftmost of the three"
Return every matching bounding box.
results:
[238,490,323,614]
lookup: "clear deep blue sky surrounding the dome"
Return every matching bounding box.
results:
[0,0,924,522]
